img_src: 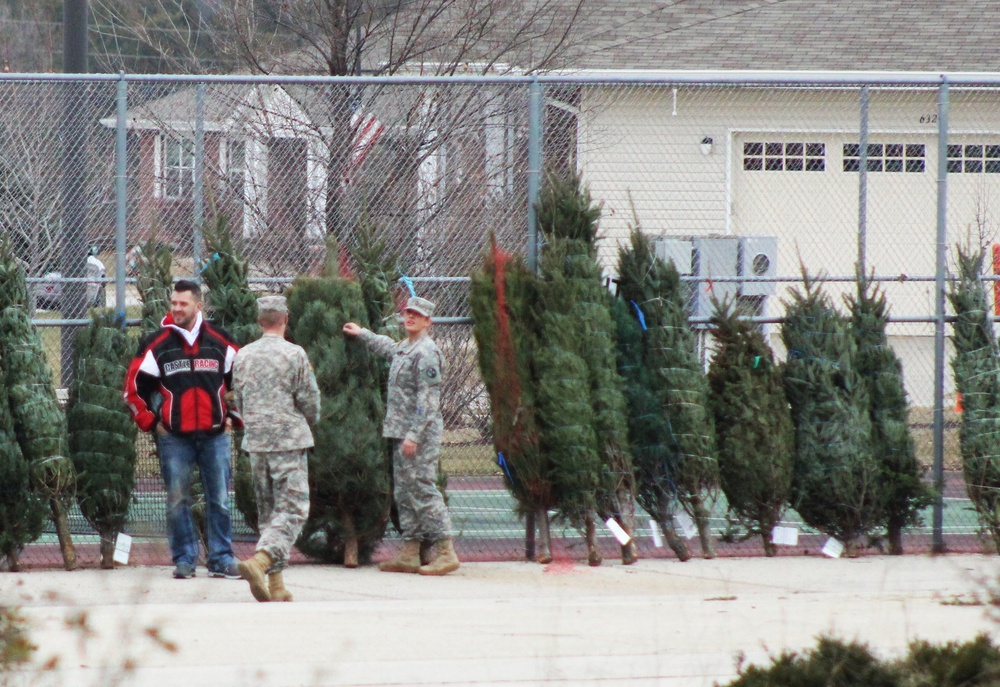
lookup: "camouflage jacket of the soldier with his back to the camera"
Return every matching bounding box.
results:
[233,334,320,452]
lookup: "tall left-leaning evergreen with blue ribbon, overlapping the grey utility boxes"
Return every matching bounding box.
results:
[618,230,719,556]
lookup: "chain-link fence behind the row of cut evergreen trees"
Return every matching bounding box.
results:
[0,73,1000,564]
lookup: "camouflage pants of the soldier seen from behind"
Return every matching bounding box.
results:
[250,450,309,572]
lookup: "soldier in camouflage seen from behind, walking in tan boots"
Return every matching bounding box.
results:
[233,296,320,601]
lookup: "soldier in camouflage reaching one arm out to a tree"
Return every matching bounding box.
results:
[344,298,459,575]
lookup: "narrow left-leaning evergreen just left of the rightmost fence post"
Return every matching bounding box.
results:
[848,280,931,554]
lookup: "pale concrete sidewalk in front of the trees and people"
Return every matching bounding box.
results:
[0,555,1000,687]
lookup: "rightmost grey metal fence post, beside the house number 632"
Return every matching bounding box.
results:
[932,77,948,553]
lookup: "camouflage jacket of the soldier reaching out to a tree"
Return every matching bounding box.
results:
[361,329,444,444]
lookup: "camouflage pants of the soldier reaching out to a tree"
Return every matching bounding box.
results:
[392,437,451,541]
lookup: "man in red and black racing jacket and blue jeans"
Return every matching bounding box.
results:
[124,280,241,579]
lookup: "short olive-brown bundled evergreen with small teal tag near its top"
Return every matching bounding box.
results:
[708,303,795,556]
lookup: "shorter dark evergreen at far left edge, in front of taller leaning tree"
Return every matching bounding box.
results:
[0,346,46,572]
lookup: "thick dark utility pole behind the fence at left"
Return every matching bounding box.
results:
[59,0,90,387]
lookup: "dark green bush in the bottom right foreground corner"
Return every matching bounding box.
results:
[727,635,1000,687]
